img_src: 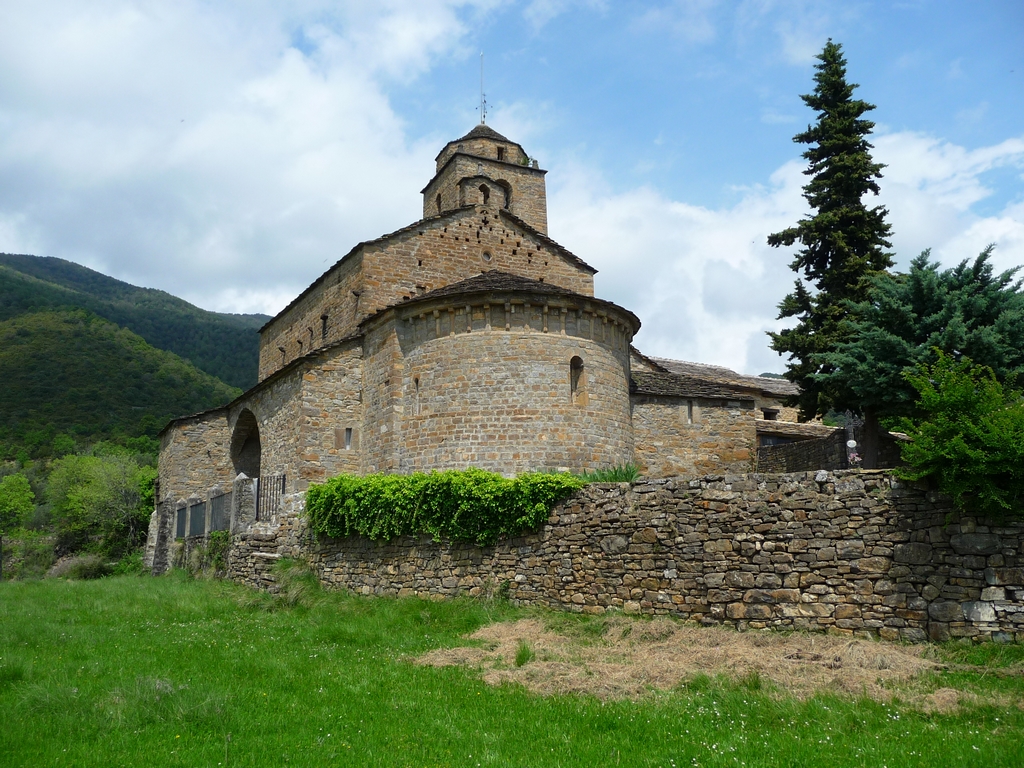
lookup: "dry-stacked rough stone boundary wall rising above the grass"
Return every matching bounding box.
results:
[230,470,1024,641]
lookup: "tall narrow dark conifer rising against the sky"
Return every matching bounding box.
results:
[768,40,892,428]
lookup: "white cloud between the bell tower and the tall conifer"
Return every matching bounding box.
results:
[549,157,804,373]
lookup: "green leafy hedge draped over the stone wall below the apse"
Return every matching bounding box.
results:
[306,469,586,545]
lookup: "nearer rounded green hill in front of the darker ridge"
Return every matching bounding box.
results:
[0,309,241,444]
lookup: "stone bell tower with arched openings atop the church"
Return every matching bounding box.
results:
[423,123,548,234]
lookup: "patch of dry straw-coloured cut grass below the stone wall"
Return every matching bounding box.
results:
[417,616,991,712]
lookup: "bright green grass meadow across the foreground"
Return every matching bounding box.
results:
[0,575,1024,768]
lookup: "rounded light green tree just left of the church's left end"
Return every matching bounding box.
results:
[46,452,157,557]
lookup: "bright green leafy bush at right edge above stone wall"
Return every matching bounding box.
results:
[898,352,1024,515]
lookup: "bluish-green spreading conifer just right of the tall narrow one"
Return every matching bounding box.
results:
[819,246,1024,428]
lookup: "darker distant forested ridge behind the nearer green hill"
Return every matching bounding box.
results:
[0,254,269,389]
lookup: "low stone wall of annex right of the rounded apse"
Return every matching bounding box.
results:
[633,395,756,477]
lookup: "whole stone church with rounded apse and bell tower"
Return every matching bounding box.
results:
[158,124,806,514]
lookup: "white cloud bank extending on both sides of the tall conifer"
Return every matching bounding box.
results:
[549,133,1024,373]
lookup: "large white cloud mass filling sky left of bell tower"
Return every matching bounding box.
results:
[0,0,495,311]
